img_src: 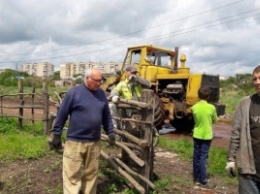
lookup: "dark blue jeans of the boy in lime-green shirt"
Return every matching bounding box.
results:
[193,138,211,185]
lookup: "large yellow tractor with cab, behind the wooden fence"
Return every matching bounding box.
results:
[102,45,225,131]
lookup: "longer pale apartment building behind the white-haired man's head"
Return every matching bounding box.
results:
[60,62,122,79]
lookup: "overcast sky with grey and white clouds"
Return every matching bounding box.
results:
[0,0,260,77]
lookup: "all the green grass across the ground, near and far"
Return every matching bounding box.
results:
[0,82,242,194]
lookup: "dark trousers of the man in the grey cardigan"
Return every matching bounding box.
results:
[238,174,260,194]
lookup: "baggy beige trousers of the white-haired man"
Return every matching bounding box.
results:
[62,140,101,194]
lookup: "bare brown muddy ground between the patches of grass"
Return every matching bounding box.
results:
[0,101,238,194]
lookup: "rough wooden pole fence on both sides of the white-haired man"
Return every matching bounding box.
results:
[0,81,156,194]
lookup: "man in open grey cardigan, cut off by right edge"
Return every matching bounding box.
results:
[226,65,260,194]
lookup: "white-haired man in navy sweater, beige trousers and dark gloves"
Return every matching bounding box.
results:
[51,68,115,194]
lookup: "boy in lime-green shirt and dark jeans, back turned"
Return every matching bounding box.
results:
[191,87,217,190]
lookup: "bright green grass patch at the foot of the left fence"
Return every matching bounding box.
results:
[0,118,48,163]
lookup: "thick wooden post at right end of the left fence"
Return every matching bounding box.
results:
[43,82,49,135]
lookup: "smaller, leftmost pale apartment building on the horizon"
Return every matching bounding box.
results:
[21,62,54,78]
